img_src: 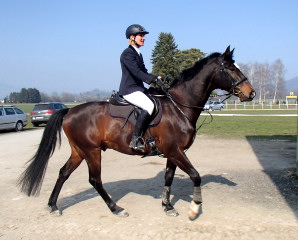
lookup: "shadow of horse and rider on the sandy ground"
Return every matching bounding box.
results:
[58,171,237,212]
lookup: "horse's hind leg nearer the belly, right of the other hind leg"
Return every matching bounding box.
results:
[86,148,129,217]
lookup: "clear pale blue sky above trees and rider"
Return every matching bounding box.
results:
[0,0,298,98]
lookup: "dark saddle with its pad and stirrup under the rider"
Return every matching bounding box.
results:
[108,93,162,157]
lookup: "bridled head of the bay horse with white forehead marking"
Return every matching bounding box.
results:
[217,46,256,102]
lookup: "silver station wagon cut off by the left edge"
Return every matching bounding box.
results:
[0,106,27,131]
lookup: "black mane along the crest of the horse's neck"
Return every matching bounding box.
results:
[171,52,221,87]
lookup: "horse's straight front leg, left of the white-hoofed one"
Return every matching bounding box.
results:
[162,159,179,217]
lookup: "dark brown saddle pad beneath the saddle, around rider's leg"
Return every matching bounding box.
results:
[109,99,162,127]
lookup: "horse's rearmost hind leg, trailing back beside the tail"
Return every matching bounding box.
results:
[48,149,83,214]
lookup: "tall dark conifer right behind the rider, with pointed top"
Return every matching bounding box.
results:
[151,32,179,79]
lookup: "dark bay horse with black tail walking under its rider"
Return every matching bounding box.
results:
[18,47,255,219]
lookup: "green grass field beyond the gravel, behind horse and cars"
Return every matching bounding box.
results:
[12,104,297,141]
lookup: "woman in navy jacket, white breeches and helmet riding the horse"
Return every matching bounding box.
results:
[119,24,161,152]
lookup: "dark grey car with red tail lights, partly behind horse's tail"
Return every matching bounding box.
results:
[30,102,67,127]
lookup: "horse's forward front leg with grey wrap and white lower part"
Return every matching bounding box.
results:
[168,150,202,220]
